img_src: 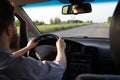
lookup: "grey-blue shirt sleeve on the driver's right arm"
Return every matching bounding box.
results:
[21,59,64,80]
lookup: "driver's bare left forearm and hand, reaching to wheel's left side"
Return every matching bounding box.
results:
[12,39,37,57]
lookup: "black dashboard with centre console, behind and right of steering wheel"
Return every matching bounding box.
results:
[32,38,115,80]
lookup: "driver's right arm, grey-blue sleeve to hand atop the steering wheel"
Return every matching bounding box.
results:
[17,39,67,80]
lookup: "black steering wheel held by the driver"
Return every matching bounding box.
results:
[29,34,59,60]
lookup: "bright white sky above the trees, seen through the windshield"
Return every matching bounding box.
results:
[24,2,116,24]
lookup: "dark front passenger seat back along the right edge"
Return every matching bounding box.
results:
[110,0,120,74]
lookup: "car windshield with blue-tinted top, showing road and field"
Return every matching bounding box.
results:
[22,0,117,38]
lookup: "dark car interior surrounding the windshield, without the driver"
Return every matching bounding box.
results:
[0,0,120,80]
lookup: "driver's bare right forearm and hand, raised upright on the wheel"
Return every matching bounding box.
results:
[55,38,67,69]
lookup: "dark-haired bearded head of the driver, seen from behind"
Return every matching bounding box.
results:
[0,0,16,46]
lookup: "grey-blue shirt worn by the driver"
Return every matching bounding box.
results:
[0,49,64,80]
